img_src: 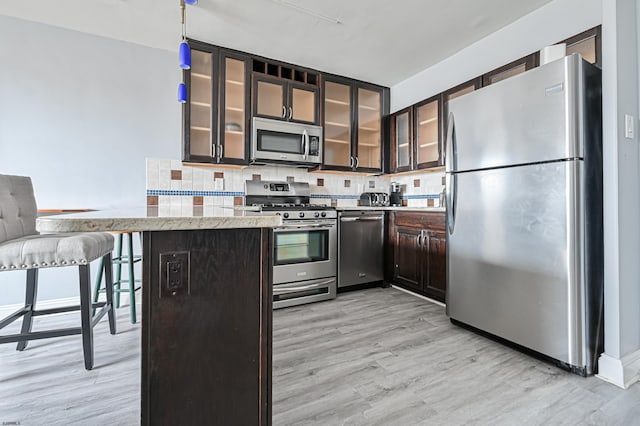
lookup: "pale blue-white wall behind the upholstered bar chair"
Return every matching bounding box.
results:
[0,16,181,305]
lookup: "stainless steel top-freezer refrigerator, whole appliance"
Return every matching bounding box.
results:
[445,54,603,375]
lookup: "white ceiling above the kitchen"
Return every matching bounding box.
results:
[0,0,551,86]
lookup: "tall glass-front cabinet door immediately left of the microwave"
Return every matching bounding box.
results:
[218,56,250,160]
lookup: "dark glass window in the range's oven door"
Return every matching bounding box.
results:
[273,229,329,265]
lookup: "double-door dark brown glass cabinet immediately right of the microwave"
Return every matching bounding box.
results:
[322,75,389,173]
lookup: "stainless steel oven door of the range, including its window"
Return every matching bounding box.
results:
[272,220,337,284]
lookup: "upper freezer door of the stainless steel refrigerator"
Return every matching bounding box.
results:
[446,55,589,172]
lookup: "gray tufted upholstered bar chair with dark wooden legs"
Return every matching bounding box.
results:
[0,175,116,370]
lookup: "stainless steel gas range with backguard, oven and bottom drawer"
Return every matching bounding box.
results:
[245,180,338,308]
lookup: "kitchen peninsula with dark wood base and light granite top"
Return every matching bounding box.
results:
[37,207,281,425]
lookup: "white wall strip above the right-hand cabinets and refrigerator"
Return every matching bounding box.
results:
[391,0,602,112]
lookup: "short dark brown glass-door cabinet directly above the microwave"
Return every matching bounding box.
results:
[252,59,320,124]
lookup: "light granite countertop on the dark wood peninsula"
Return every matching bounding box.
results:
[36,206,282,233]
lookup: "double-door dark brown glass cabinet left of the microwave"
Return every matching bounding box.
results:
[182,40,250,164]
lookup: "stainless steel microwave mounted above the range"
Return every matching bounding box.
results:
[251,117,322,166]
